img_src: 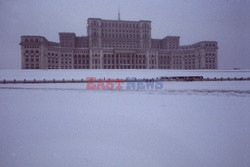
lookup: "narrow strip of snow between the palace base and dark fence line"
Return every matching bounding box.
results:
[0,69,250,80]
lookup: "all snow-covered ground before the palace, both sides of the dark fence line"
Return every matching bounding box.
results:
[0,70,250,167]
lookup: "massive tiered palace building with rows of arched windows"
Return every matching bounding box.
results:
[20,18,218,69]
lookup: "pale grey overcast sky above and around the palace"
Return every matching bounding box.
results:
[0,0,250,69]
